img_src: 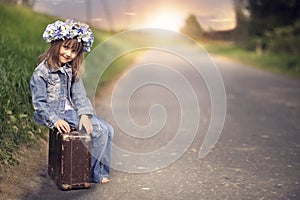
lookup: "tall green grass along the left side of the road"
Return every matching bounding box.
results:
[0,3,133,169]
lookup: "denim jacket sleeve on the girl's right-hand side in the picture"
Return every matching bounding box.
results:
[71,79,94,116]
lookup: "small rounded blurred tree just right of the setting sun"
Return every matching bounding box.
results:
[180,15,204,39]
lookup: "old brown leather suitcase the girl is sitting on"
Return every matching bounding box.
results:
[48,129,91,190]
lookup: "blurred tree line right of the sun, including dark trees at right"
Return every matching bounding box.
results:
[181,0,300,54]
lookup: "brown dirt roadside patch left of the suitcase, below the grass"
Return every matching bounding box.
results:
[0,139,48,200]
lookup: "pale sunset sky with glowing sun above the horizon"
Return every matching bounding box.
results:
[34,0,235,31]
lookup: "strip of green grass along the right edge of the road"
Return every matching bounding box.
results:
[200,41,300,78]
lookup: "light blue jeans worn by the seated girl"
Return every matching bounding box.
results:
[64,110,114,183]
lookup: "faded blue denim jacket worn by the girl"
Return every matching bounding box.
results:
[30,61,93,128]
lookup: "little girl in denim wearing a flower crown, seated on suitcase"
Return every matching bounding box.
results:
[30,20,114,183]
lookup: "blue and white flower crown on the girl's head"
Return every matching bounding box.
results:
[43,19,94,52]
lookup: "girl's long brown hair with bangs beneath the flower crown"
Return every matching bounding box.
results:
[38,39,83,80]
